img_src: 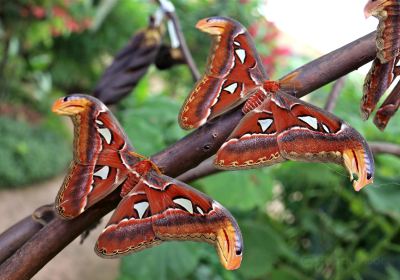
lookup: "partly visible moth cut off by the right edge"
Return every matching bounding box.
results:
[361,0,400,130]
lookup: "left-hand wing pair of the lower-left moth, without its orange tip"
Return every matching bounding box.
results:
[55,95,137,219]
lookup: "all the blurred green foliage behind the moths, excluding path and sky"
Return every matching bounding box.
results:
[0,0,400,280]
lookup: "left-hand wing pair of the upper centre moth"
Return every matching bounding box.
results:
[179,17,267,129]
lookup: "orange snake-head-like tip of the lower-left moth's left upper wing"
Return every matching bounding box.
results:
[52,94,105,116]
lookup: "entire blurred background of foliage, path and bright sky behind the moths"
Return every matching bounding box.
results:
[0,0,400,280]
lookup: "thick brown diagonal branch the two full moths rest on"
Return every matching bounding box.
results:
[0,33,375,280]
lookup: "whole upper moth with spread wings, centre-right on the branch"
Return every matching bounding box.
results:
[179,17,374,191]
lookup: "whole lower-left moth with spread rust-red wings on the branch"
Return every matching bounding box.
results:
[52,94,243,269]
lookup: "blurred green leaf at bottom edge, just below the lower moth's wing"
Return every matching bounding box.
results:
[118,242,209,280]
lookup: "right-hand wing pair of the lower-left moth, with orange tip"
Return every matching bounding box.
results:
[95,172,243,269]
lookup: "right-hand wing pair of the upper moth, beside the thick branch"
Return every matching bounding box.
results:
[216,92,374,190]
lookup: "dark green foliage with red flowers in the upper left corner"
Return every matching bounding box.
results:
[0,0,150,108]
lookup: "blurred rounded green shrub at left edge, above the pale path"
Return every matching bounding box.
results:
[0,117,71,187]
